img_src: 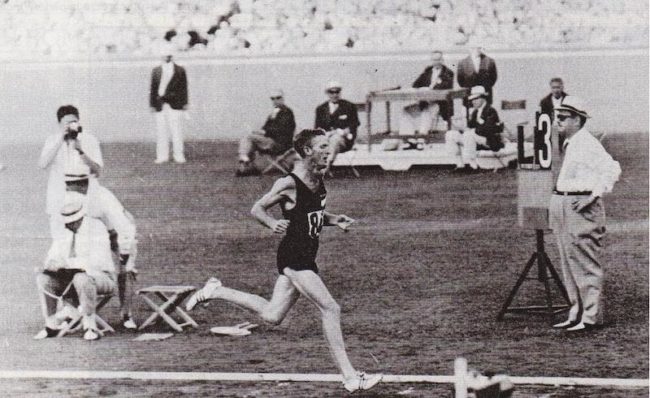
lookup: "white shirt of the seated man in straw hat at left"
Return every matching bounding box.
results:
[45,217,115,276]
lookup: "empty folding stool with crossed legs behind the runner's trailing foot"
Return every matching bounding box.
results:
[138,285,199,332]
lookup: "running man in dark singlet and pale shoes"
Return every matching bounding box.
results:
[187,129,382,392]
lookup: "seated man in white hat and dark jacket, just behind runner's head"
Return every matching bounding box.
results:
[315,81,360,171]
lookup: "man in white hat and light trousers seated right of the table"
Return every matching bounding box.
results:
[445,86,504,171]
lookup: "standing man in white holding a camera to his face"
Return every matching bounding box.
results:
[38,105,104,239]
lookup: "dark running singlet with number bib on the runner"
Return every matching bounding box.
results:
[278,173,327,274]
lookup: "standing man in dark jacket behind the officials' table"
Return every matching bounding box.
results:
[458,46,497,105]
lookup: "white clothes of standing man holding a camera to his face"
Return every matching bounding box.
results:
[41,132,104,215]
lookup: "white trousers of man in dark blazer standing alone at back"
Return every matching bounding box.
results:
[156,104,185,162]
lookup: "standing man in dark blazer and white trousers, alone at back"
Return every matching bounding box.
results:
[149,42,188,164]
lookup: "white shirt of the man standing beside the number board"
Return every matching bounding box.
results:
[556,128,621,196]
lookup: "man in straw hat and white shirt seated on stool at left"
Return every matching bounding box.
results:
[34,194,118,340]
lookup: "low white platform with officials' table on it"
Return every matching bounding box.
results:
[333,88,533,171]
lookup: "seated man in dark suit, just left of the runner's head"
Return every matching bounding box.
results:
[236,90,296,176]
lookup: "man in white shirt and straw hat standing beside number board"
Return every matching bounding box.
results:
[549,95,621,332]
